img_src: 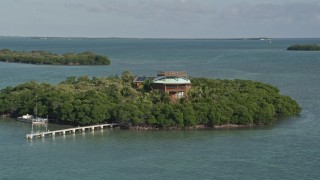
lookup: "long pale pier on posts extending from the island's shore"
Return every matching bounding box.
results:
[26,123,118,139]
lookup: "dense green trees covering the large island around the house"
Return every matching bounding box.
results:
[0,71,301,128]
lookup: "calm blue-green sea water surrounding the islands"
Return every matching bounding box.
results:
[0,37,320,179]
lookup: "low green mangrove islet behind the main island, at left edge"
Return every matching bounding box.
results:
[0,49,110,65]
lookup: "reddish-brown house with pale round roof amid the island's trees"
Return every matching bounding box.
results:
[133,71,191,102]
